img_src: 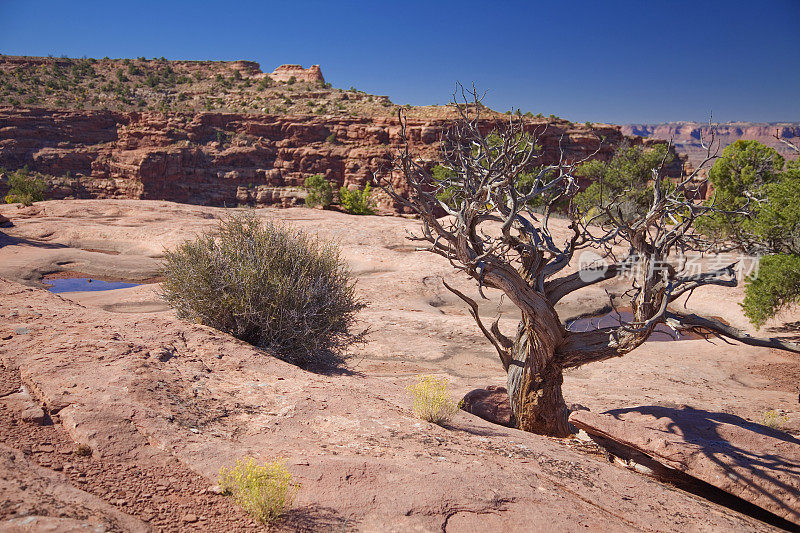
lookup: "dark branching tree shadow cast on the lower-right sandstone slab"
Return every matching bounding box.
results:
[605,406,800,527]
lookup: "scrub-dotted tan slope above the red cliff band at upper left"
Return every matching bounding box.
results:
[0,55,397,116]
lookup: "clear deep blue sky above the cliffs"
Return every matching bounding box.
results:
[0,0,800,123]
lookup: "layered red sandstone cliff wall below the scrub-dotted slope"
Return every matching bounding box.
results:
[0,108,680,210]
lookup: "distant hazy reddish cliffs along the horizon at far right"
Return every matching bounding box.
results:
[622,122,800,166]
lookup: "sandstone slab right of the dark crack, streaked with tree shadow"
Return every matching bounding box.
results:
[570,406,800,525]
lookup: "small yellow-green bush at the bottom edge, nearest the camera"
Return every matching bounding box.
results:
[219,457,299,523]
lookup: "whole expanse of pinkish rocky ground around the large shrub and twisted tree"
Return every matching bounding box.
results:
[0,200,800,531]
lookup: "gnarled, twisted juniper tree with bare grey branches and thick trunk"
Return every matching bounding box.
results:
[378,88,800,436]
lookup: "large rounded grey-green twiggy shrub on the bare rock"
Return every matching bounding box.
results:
[162,212,364,365]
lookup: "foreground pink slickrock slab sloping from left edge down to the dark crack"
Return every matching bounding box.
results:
[0,279,766,531]
